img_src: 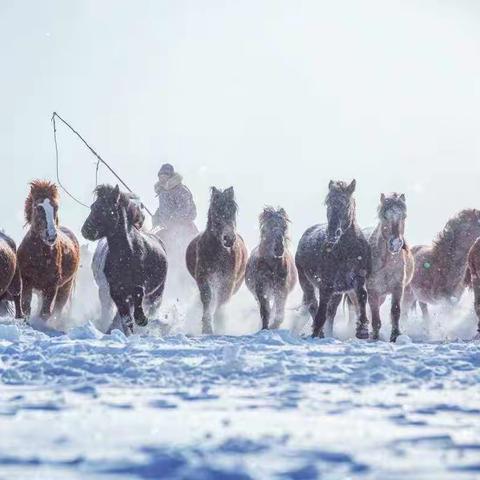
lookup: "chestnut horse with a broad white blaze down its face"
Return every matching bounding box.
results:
[18,180,80,320]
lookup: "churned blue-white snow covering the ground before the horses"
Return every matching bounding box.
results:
[0,306,480,480]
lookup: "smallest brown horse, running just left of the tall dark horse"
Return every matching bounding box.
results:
[245,207,297,330]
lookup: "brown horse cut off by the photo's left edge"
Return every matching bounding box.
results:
[0,231,23,319]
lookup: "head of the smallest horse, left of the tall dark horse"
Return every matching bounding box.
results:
[259,207,290,258]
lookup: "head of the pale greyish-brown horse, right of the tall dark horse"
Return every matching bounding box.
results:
[378,193,407,255]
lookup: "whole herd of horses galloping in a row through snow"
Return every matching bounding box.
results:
[0,180,480,341]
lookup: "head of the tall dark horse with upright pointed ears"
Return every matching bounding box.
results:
[325,180,356,245]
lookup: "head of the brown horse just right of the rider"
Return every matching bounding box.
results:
[207,187,238,249]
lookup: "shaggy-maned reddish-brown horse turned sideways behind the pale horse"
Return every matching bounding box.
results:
[402,209,480,321]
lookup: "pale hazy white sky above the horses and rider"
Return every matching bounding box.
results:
[0,0,480,247]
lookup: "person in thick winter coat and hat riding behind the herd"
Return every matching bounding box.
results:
[153,163,197,228]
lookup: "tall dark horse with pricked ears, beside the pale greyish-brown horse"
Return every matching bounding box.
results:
[295,180,371,339]
